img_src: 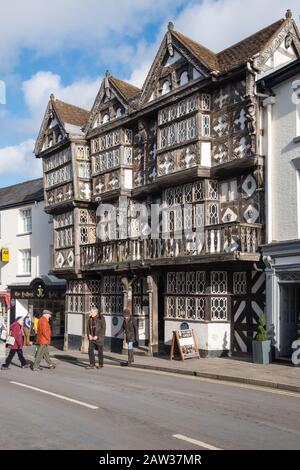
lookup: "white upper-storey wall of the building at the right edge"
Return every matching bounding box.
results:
[262,74,300,242]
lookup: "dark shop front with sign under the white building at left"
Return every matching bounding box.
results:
[9,276,66,338]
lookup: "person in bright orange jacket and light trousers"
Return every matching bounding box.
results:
[32,310,56,371]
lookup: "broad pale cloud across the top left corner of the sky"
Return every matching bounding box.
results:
[0,0,185,69]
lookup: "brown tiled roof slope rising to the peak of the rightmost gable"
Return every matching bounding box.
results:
[216,18,286,72]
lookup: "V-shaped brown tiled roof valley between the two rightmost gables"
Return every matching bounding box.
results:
[172,19,286,72]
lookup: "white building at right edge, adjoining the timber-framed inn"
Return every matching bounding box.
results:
[258,60,300,357]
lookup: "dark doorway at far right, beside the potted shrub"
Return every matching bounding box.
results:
[279,284,300,357]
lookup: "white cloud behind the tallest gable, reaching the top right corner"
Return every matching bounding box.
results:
[130,0,299,86]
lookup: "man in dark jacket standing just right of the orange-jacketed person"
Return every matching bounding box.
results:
[86,307,106,369]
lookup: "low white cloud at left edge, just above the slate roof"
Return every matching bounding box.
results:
[0,139,42,179]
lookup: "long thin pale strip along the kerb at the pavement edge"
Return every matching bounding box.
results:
[105,364,300,398]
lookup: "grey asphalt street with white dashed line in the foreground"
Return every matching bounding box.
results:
[0,361,300,450]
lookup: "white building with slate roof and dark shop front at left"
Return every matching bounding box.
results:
[0,179,65,336]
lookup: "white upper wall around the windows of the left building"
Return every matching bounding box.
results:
[0,201,53,291]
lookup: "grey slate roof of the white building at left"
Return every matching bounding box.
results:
[0,178,44,210]
